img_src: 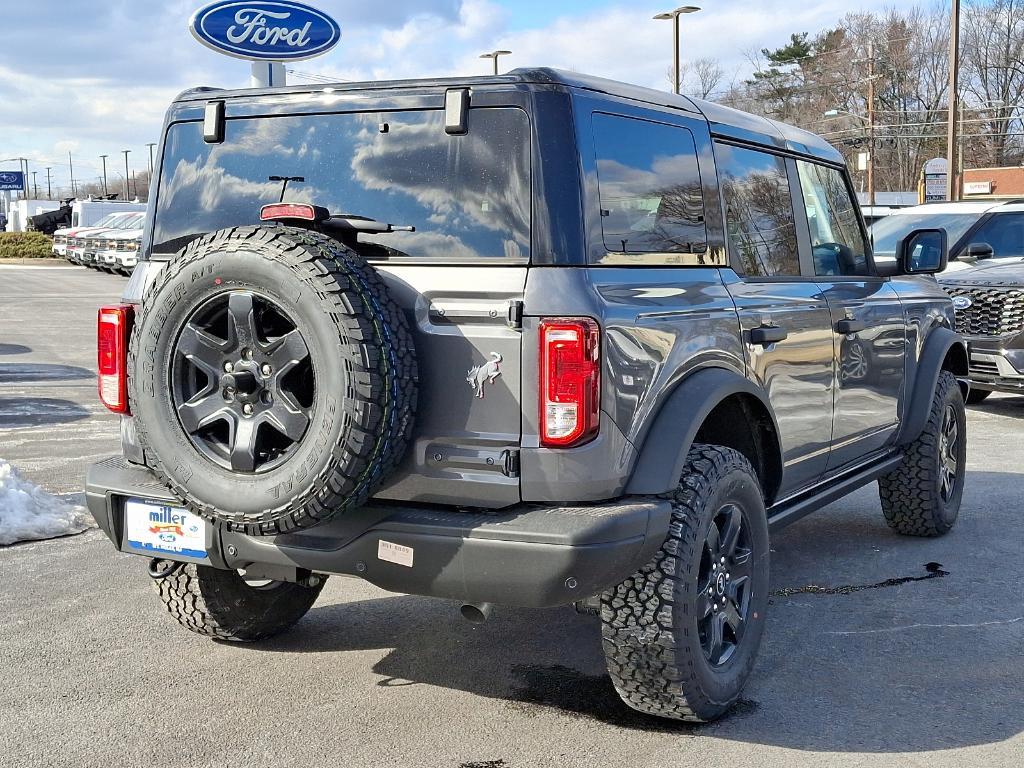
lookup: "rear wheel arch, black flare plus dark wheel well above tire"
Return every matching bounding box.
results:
[626,368,782,505]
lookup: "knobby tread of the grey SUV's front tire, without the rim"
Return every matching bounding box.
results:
[879,371,967,537]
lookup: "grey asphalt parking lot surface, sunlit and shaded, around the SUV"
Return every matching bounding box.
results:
[0,266,1024,768]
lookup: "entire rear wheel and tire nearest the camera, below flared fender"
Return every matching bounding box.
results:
[601,444,769,722]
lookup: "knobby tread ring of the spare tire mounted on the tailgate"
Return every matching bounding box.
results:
[128,225,418,536]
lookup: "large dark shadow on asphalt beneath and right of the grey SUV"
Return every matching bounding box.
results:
[241,472,1024,753]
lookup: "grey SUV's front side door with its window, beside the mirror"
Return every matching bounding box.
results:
[796,160,906,471]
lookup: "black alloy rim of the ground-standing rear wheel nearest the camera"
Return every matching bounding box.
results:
[696,504,752,667]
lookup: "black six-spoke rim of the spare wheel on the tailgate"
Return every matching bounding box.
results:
[170,290,315,472]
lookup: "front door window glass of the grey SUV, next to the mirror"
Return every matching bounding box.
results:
[797,160,870,276]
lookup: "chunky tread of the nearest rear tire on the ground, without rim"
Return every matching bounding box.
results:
[601,444,758,723]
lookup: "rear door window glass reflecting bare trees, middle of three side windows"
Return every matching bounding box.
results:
[715,144,800,278]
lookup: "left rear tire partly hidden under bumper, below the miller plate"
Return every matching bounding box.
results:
[153,563,326,643]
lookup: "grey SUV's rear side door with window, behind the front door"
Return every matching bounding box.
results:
[715,142,834,495]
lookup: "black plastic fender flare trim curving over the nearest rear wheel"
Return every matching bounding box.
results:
[626,368,781,495]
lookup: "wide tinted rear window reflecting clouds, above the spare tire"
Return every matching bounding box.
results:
[153,109,530,261]
